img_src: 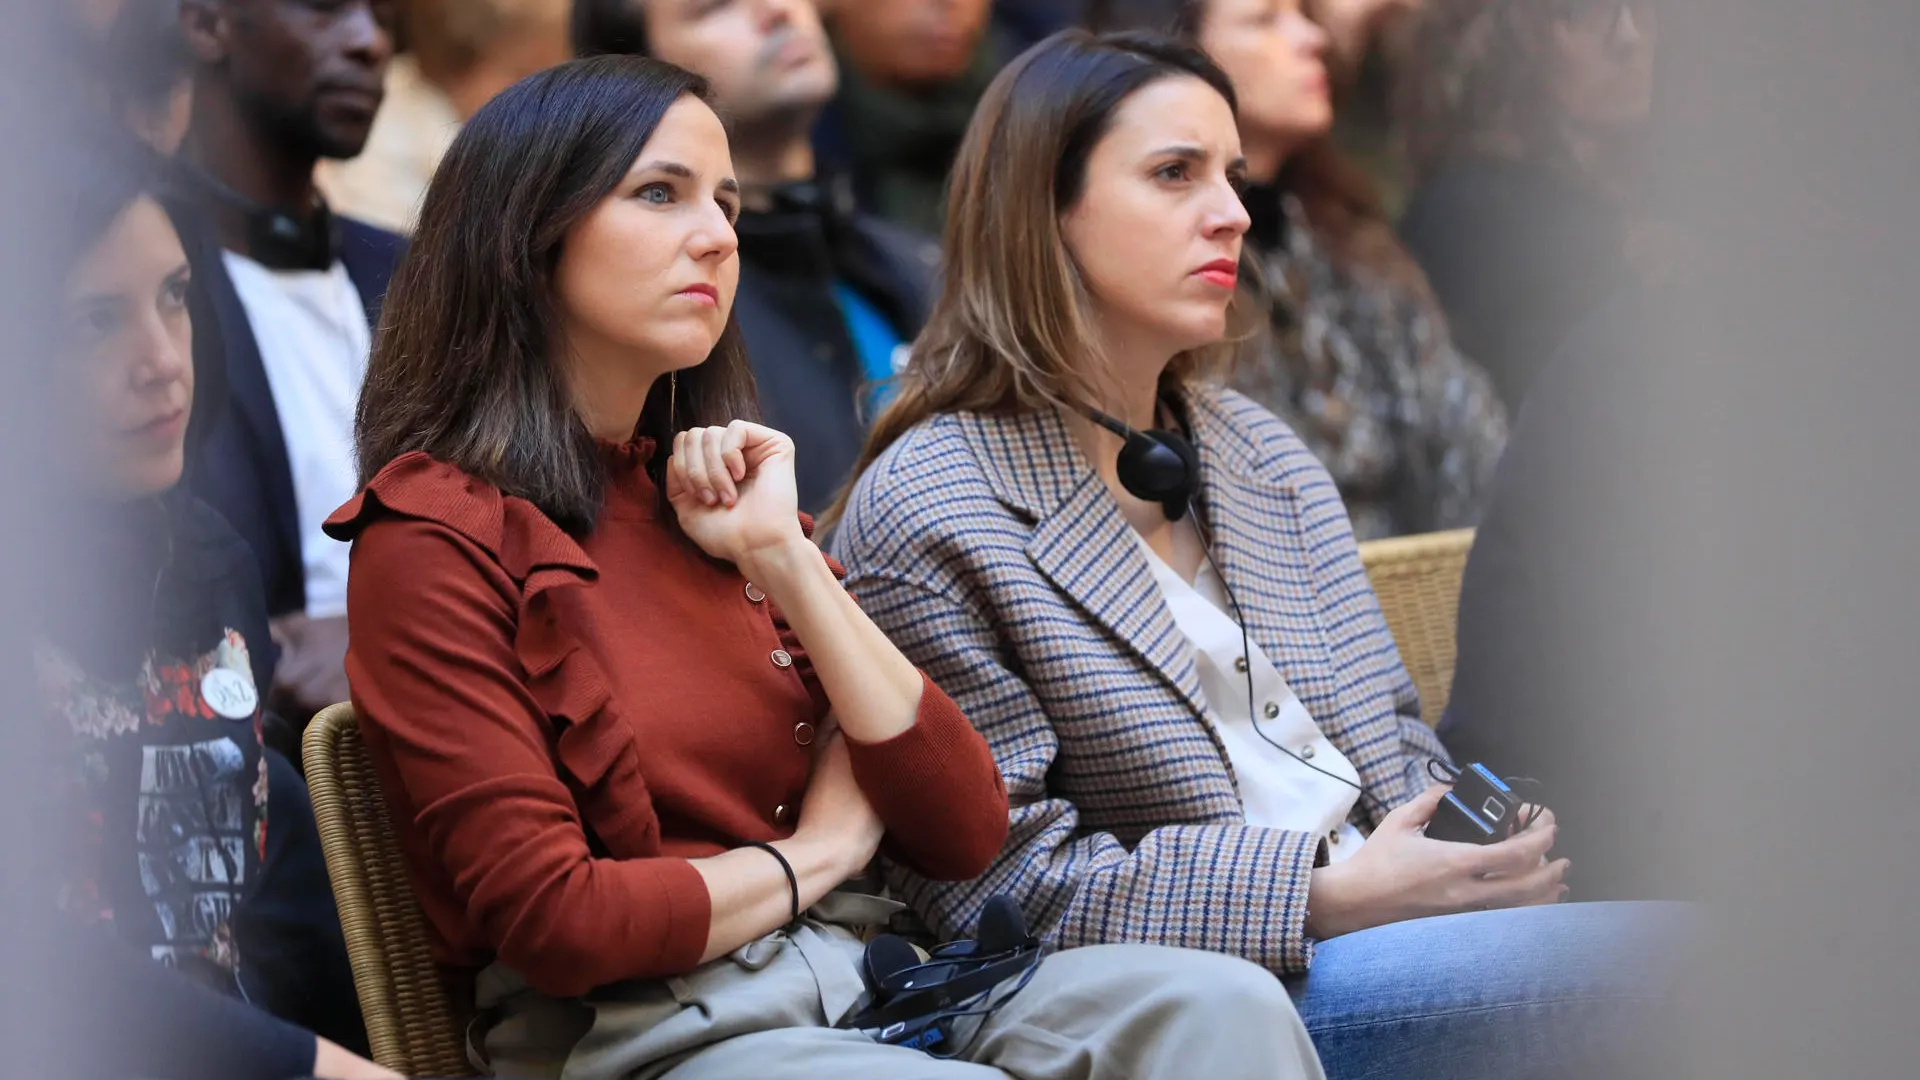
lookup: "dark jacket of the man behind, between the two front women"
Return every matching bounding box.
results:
[733,184,939,513]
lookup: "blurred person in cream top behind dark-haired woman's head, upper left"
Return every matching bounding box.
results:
[317,0,572,233]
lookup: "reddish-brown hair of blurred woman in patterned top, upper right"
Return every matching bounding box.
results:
[1089,0,1434,304]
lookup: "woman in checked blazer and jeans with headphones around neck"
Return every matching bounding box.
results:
[833,29,1678,1080]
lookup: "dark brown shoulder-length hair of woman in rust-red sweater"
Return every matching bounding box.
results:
[355,56,756,536]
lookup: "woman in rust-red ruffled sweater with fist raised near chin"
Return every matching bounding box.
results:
[328,58,1319,1080]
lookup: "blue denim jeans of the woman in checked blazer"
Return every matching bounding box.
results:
[1286,903,1693,1080]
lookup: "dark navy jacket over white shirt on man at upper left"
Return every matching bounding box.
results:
[167,202,407,615]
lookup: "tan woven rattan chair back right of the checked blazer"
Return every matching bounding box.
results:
[1359,528,1473,724]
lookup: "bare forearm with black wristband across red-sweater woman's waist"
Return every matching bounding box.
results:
[693,834,860,963]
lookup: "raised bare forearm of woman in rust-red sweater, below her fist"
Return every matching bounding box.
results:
[739,536,924,744]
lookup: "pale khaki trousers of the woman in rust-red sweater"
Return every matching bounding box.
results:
[476,907,1325,1080]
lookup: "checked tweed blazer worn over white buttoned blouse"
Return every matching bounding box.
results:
[833,386,1444,974]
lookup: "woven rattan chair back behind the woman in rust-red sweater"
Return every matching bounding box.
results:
[301,703,474,1076]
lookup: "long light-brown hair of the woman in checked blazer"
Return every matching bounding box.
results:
[822,29,1252,528]
